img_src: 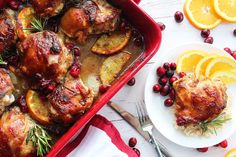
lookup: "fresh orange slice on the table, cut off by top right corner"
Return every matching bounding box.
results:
[214,0,236,22]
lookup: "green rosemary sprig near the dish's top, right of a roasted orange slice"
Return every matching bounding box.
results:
[24,17,46,32]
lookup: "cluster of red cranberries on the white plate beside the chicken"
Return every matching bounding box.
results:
[153,63,185,107]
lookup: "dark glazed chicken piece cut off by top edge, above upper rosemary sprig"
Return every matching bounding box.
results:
[32,0,65,18]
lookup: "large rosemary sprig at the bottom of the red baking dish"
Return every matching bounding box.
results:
[26,124,52,157]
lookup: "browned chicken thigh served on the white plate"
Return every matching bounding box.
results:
[173,75,228,126]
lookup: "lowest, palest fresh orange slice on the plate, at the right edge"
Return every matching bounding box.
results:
[211,71,236,84]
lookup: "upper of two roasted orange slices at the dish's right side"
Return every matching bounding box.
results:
[92,30,131,55]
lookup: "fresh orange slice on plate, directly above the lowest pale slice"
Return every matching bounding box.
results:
[205,56,236,77]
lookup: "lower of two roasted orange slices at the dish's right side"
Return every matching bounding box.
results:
[100,52,131,85]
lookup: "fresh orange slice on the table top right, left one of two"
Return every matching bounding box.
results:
[184,0,221,29]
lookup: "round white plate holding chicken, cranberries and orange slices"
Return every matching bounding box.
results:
[145,43,236,148]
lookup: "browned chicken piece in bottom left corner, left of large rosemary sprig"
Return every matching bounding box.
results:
[0,107,35,157]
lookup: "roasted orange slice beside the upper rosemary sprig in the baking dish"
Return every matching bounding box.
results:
[16,7,35,40]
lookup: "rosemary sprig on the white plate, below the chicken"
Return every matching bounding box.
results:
[199,113,231,135]
